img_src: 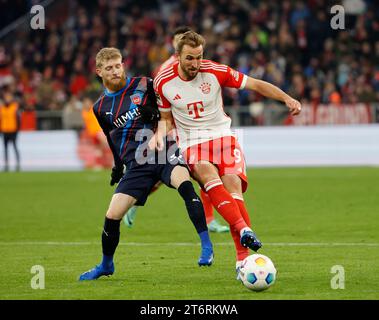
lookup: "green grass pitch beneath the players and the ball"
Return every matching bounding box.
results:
[0,167,379,300]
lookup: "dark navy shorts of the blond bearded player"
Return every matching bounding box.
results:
[115,163,182,206]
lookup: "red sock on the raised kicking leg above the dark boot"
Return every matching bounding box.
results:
[204,179,248,232]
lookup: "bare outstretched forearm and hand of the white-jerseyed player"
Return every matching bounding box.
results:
[245,77,301,116]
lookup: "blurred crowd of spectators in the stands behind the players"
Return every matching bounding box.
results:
[0,0,379,119]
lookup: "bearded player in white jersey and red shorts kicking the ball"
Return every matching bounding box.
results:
[149,31,301,278]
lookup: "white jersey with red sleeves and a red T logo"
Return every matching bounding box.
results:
[154,60,247,150]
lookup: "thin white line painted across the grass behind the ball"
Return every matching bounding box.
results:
[0,241,379,247]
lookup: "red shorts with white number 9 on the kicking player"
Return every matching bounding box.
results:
[183,136,248,192]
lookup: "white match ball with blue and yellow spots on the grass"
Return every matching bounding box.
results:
[240,254,276,291]
